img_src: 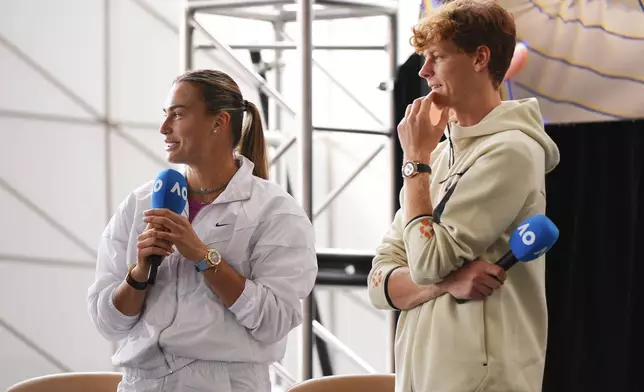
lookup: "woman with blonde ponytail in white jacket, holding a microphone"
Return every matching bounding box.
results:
[88,70,317,392]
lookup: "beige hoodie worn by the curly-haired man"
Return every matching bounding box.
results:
[369,99,559,392]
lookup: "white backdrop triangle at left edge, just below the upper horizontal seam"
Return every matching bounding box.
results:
[0,119,106,257]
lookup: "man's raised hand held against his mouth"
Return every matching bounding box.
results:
[398,92,449,163]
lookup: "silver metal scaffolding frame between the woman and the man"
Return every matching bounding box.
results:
[179,0,399,381]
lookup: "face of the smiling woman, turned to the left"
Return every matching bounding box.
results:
[160,82,232,165]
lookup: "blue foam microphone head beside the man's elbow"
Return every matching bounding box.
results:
[510,215,559,261]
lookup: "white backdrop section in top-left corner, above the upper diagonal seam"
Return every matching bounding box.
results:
[0,0,105,114]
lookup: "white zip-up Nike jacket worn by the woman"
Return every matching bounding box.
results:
[88,156,317,377]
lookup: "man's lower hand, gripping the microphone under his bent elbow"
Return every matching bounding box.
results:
[440,261,507,300]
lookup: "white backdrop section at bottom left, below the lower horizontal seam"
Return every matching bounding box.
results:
[0,263,111,388]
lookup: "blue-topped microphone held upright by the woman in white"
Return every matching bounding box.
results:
[148,169,188,284]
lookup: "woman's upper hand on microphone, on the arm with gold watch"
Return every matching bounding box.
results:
[143,209,208,263]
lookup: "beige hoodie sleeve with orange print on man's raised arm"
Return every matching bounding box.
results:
[402,138,544,285]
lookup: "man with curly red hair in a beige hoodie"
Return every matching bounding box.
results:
[369,0,559,392]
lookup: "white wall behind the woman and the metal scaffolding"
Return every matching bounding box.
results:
[0,0,416,388]
